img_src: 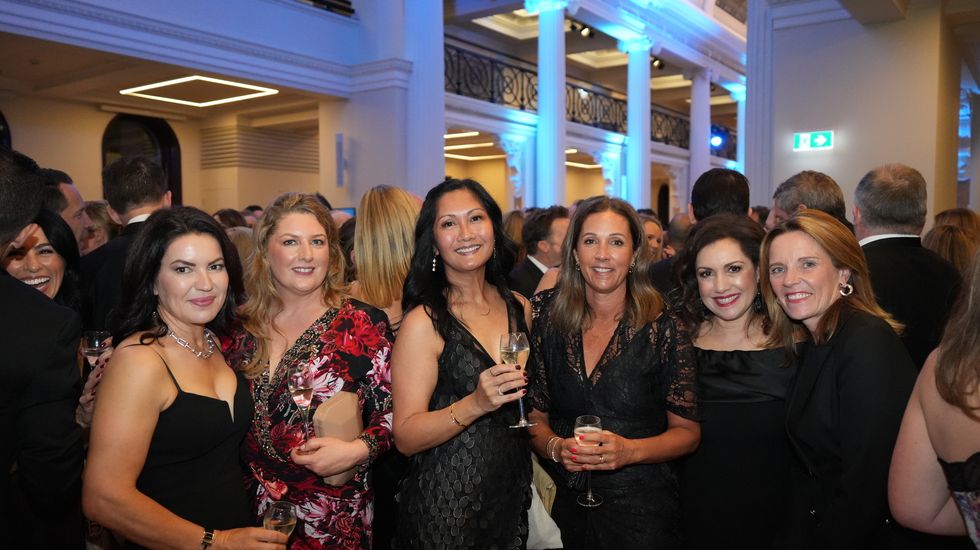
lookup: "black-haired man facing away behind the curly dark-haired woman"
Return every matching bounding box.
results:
[650,168,751,298]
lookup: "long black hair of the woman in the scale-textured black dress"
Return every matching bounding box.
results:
[402,178,521,339]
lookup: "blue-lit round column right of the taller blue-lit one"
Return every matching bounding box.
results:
[619,37,653,208]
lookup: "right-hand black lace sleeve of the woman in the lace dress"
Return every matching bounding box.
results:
[655,310,701,421]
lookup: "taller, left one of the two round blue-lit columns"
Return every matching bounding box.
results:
[524,0,568,207]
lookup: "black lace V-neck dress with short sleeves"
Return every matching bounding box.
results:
[529,289,699,550]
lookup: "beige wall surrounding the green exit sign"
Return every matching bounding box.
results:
[770,0,959,223]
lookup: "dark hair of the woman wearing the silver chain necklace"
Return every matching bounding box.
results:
[112,206,245,345]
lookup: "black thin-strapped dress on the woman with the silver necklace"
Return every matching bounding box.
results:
[126,367,255,548]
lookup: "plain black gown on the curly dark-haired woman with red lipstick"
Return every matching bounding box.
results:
[681,348,795,550]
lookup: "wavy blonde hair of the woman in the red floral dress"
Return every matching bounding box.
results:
[240,193,347,378]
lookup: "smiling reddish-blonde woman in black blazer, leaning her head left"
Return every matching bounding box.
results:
[760,209,915,549]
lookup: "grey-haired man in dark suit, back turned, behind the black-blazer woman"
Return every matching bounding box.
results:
[854,164,960,368]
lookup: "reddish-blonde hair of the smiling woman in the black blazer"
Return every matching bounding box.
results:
[759,208,903,347]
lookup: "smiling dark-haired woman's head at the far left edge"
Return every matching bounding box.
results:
[3,209,80,311]
